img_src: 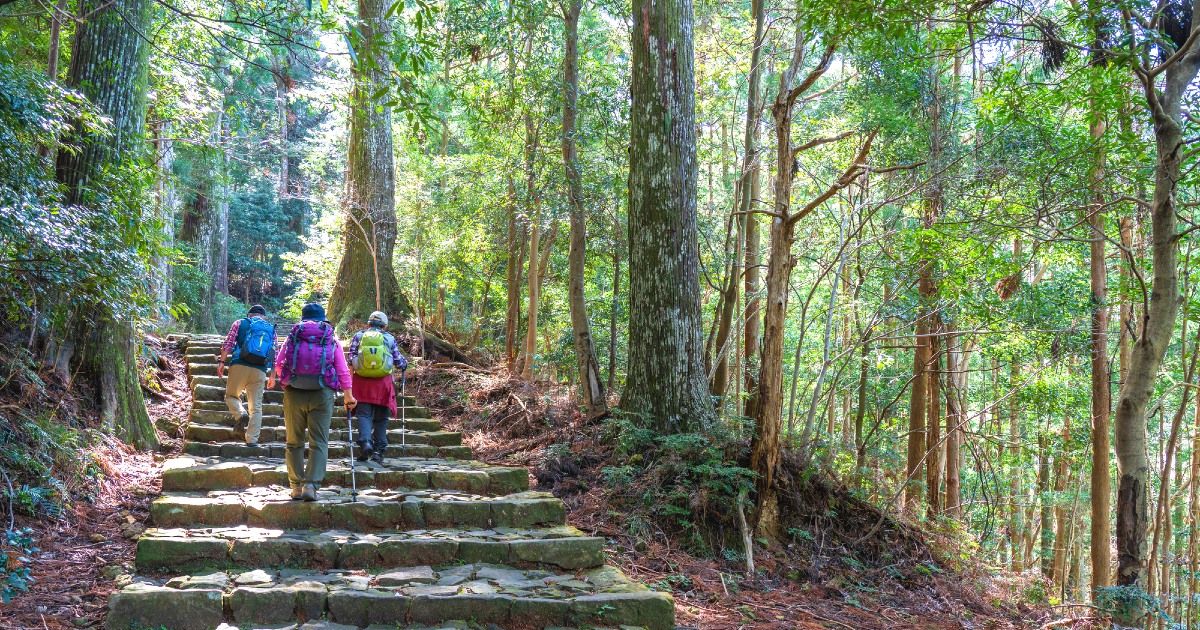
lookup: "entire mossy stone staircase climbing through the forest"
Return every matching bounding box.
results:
[107,336,674,630]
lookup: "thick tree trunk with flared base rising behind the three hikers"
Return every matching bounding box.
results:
[329,0,413,325]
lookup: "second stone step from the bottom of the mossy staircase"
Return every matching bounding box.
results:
[137,526,604,572]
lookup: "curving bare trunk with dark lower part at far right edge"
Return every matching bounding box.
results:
[1114,18,1200,625]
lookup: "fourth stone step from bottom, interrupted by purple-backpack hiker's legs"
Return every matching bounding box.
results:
[162,457,529,497]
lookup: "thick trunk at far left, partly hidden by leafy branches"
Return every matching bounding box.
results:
[56,0,158,449]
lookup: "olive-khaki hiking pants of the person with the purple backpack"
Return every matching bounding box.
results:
[283,388,335,487]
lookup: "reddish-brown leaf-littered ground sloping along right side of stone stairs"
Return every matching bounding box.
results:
[409,357,1075,630]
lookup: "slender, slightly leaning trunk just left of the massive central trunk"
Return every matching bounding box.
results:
[563,0,608,419]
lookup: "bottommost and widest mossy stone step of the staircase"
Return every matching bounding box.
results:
[108,564,674,630]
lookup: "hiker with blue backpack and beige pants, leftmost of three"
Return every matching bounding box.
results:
[217,304,275,444]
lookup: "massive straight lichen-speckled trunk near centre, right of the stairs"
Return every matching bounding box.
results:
[622,0,714,433]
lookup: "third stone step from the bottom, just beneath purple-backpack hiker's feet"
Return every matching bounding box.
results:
[150,486,566,532]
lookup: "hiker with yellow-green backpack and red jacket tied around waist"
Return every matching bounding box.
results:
[349,311,408,464]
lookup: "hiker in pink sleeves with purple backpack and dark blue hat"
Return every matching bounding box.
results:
[268,302,355,500]
